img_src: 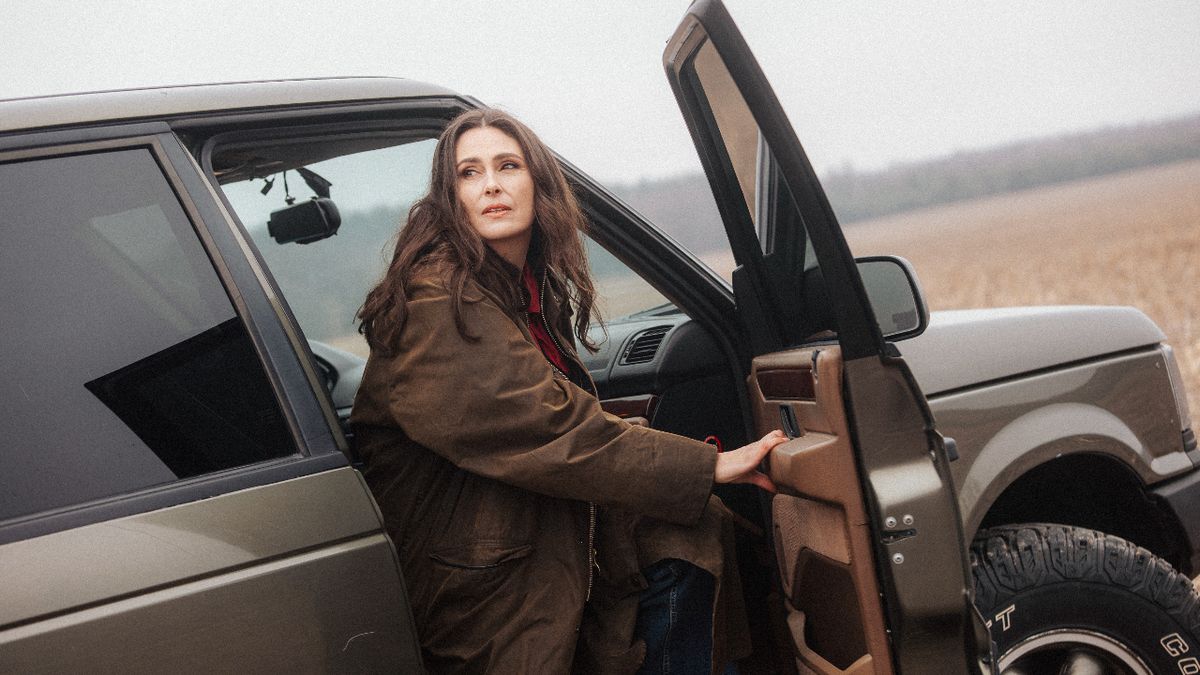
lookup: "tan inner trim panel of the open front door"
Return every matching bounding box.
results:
[748,346,892,675]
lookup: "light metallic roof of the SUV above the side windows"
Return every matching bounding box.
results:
[0,77,456,133]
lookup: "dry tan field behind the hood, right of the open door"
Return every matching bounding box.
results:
[845,161,1200,420]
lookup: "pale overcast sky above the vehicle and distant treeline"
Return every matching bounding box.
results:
[9,0,1200,183]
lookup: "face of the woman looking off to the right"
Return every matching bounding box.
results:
[455,126,534,268]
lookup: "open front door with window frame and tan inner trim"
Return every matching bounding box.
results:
[664,0,989,674]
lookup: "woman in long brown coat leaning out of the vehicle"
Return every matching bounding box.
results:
[352,109,784,673]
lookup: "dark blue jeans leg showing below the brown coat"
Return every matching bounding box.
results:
[634,558,737,675]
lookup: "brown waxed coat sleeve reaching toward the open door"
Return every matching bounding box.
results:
[365,276,716,524]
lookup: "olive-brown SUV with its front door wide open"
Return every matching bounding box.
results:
[0,0,1200,674]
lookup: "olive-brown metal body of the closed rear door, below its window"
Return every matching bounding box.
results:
[0,467,420,673]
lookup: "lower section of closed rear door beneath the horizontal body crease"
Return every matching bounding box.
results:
[0,534,408,674]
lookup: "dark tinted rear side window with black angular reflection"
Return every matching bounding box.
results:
[0,149,298,521]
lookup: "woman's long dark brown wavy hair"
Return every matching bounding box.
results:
[358,108,599,353]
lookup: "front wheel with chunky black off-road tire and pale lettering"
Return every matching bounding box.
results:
[971,524,1200,675]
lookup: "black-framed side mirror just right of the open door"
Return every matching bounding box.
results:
[854,256,929,341]
